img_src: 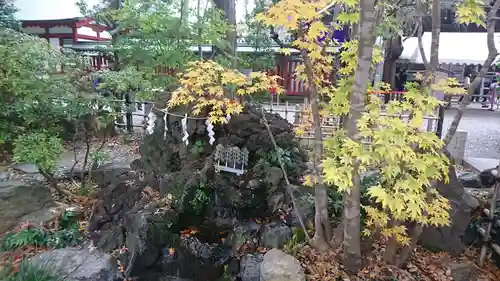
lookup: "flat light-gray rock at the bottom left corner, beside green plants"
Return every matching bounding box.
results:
[29,248,119,281]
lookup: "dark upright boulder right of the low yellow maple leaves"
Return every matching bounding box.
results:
[420,165,473,256]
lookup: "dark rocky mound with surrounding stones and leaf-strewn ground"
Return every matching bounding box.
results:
[0,103,498,281]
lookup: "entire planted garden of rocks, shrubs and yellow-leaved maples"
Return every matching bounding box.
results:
[0,0,500,281]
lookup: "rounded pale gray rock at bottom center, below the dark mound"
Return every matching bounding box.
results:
[260,249,306,281]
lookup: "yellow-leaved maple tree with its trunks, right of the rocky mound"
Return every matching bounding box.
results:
[258,0,490,271]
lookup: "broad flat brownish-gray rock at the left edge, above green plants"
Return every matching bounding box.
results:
[0,181,55,234]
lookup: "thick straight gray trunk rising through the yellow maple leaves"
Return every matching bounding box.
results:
[343,0,375,272]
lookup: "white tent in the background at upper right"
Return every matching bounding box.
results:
[400,32,500,64]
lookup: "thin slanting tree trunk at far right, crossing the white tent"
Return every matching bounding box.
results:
[444,0,500,144]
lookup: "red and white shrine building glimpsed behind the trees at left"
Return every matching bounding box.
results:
[12,0,328,96]
